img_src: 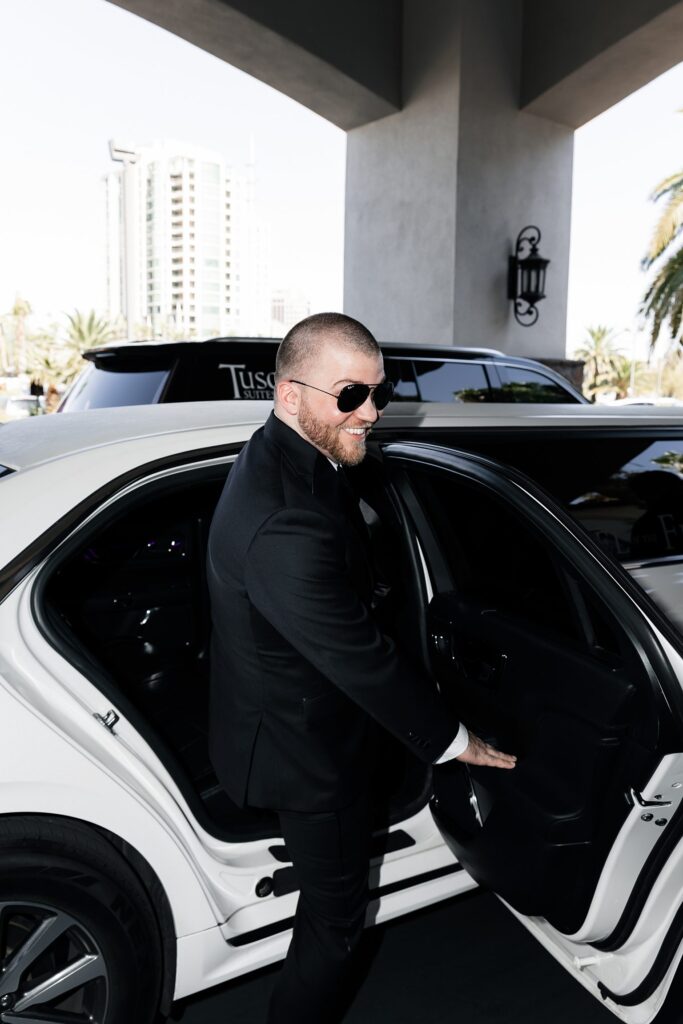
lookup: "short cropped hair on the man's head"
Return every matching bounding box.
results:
[275,313,382,383]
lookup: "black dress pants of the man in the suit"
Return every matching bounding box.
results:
[267,794,371,1024]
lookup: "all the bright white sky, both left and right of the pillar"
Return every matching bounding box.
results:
[0,0,683,355]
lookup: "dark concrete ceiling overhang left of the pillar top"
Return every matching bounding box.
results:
[112,0,402,130]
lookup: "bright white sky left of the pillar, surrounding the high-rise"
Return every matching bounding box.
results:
[0,0,346,319]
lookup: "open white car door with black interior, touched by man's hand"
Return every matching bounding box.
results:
[384,444,683,1024]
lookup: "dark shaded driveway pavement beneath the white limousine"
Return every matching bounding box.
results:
[180,892,616,1024]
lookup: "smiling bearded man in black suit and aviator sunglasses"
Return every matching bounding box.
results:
[208,313,515,1024]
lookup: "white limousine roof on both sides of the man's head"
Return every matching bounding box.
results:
[0,401,683,477]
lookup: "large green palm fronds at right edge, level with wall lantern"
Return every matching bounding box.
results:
[639,171,683,349]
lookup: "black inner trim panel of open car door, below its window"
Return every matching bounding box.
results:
[431,597,644,932]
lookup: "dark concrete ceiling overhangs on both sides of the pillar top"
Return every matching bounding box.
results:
[111,0,683,130]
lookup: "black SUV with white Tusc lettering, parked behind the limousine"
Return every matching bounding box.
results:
[59,338,587,412]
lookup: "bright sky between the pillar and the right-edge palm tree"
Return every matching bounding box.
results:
[569,65,683,358]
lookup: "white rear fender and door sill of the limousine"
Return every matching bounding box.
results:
[7,552,475,997]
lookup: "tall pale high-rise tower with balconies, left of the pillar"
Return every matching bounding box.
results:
[105,141,270,338]
